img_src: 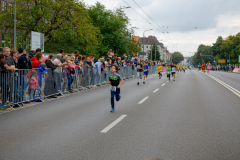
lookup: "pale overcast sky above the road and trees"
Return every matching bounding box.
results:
[83,0,240,56]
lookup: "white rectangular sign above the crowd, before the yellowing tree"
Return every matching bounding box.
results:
[31,31,44,52]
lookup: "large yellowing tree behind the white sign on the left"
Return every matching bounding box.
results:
[0,0,101,54]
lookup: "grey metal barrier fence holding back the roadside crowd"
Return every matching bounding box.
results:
[0,66,157,110]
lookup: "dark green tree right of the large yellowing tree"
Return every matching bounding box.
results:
[88,2,140,56]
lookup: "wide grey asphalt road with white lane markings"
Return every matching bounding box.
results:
[0,70,240,160]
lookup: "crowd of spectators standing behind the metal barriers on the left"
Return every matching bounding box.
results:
[0,47,158,108]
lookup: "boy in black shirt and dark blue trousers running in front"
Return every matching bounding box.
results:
[108,64,123,112]
